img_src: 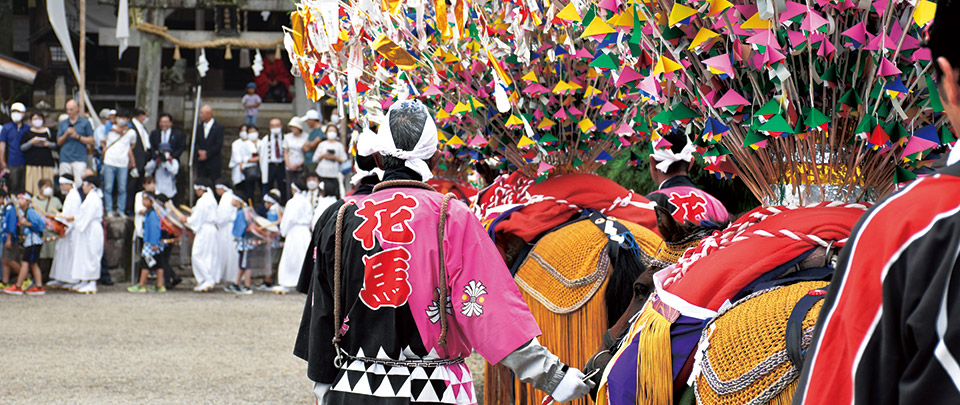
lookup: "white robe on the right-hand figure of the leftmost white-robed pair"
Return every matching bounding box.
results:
[70,189,103,281]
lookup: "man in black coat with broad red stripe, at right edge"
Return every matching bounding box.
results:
[794,2,960,404]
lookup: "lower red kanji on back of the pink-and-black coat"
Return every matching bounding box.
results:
[360,247,410,310]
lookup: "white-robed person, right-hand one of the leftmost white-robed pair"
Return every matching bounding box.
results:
[71,174,104,294]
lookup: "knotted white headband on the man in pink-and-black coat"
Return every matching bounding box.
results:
[368,100,437,181]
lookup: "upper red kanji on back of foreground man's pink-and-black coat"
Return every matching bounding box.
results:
[353,193,417,250]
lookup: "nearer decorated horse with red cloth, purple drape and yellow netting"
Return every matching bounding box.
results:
[586,203,866,404]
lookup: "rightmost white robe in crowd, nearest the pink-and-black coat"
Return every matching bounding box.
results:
[277,193,313,287]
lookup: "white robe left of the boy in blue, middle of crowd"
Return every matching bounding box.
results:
[187,191,220,285]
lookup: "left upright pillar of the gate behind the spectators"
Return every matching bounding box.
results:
[136,8,164,130]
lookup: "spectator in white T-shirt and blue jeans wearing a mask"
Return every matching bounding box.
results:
[103,110,137,217]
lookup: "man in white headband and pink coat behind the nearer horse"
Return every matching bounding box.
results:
[646,132,730,225]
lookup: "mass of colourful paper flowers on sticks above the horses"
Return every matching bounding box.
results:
[285,0,954,202]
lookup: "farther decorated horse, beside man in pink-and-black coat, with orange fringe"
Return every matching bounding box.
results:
[477,173,708,404]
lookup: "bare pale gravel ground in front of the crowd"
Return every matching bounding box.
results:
[0,283,483,404]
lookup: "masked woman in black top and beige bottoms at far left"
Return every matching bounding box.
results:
[20,111,57,195]
